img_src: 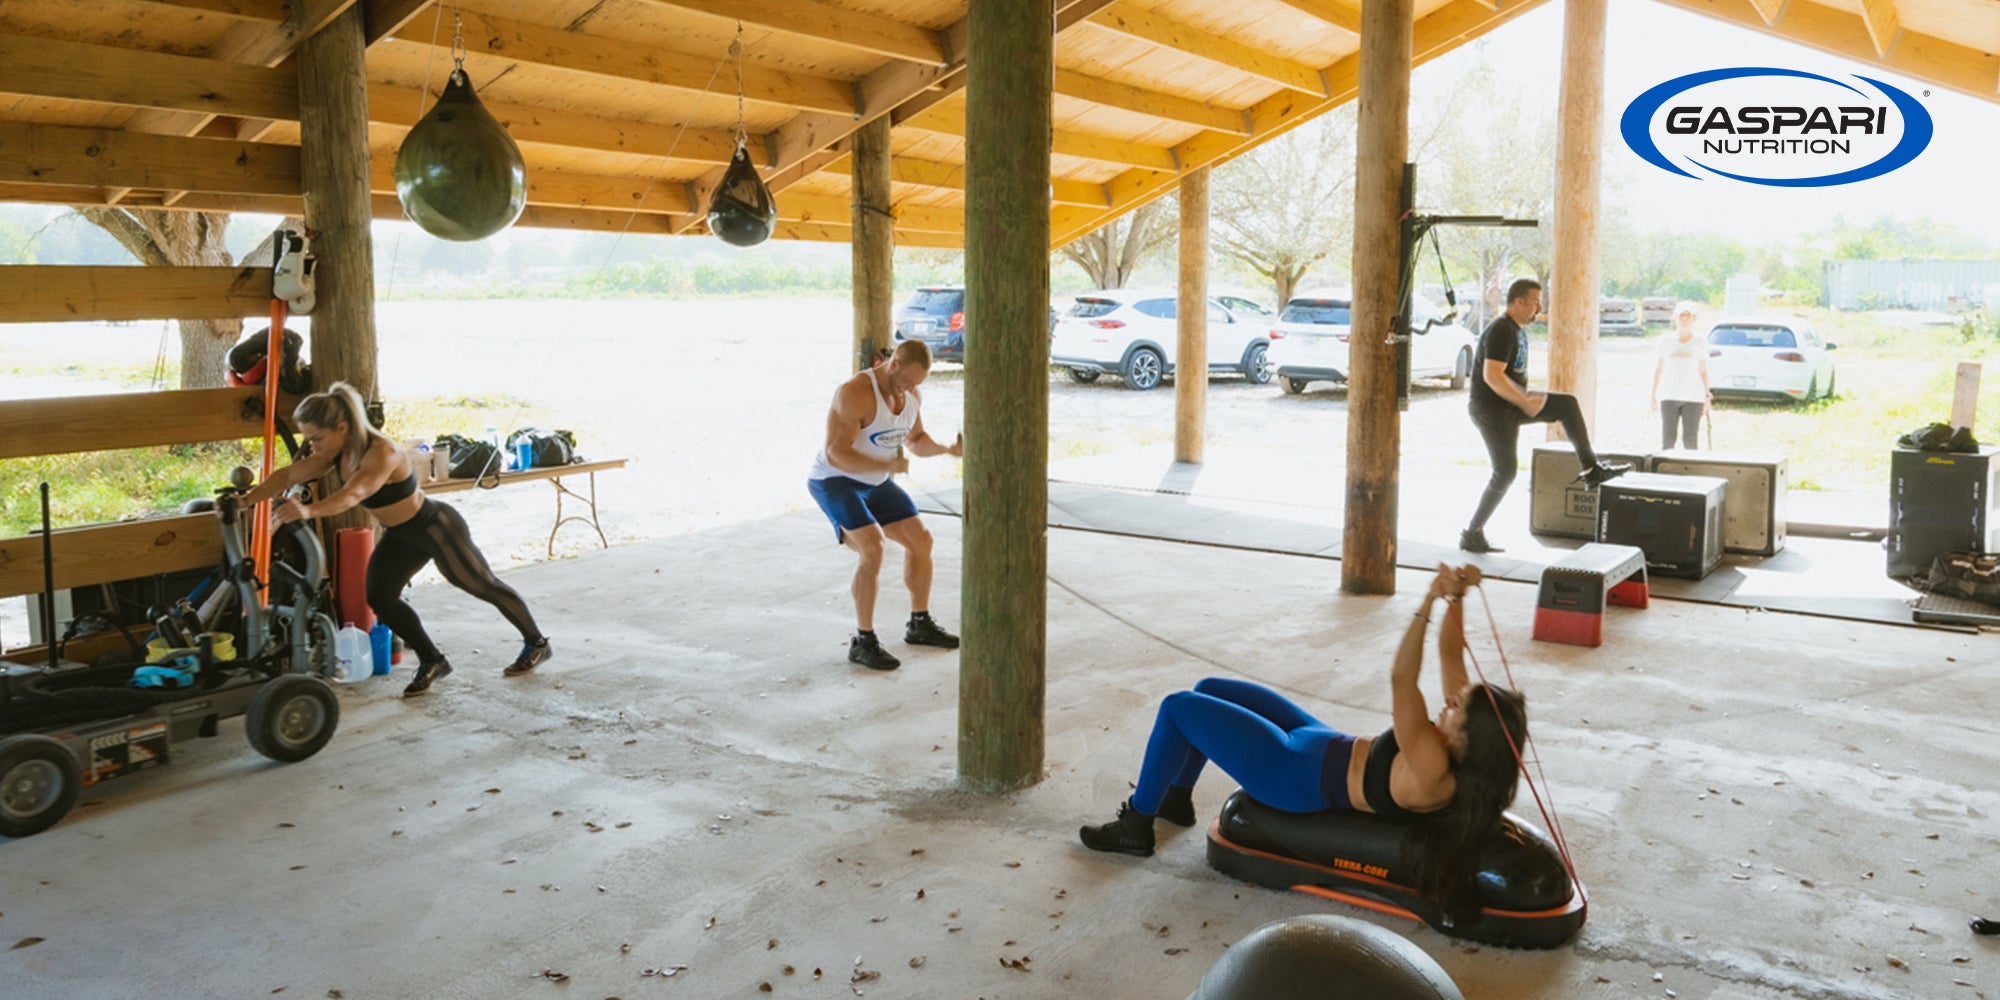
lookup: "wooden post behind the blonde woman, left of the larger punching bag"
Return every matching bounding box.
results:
[298,4,376,400]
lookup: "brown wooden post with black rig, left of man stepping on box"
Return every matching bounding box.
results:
[1340,0,1416,594]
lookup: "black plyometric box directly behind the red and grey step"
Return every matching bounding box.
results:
[1598,472,1728,580]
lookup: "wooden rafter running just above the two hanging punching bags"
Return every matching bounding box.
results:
[396,10,856,114]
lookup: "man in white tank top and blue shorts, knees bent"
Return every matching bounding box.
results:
[806,340,964,670]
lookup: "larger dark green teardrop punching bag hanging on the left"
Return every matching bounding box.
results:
[396,70,528,242]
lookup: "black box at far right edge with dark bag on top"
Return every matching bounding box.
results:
[1886,448,2000,580]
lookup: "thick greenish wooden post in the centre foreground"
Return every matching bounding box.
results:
[958,0,1056,794]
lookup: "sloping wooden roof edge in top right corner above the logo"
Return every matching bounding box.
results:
[1660,0,2000,100]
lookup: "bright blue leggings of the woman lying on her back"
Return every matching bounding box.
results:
[1132,678,1354,816]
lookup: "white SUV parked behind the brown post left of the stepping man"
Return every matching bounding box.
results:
[1266,290,1472,394]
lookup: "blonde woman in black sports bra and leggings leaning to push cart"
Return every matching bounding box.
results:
[244,382,550,698]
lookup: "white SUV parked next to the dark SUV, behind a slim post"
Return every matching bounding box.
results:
[1048,288,1270,390]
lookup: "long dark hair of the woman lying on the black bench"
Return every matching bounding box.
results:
[1402,684,1528,926]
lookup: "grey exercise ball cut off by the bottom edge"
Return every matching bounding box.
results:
[1188,914,1466,1000]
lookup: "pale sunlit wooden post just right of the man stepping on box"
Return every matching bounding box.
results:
[1548,0,1606,440]
